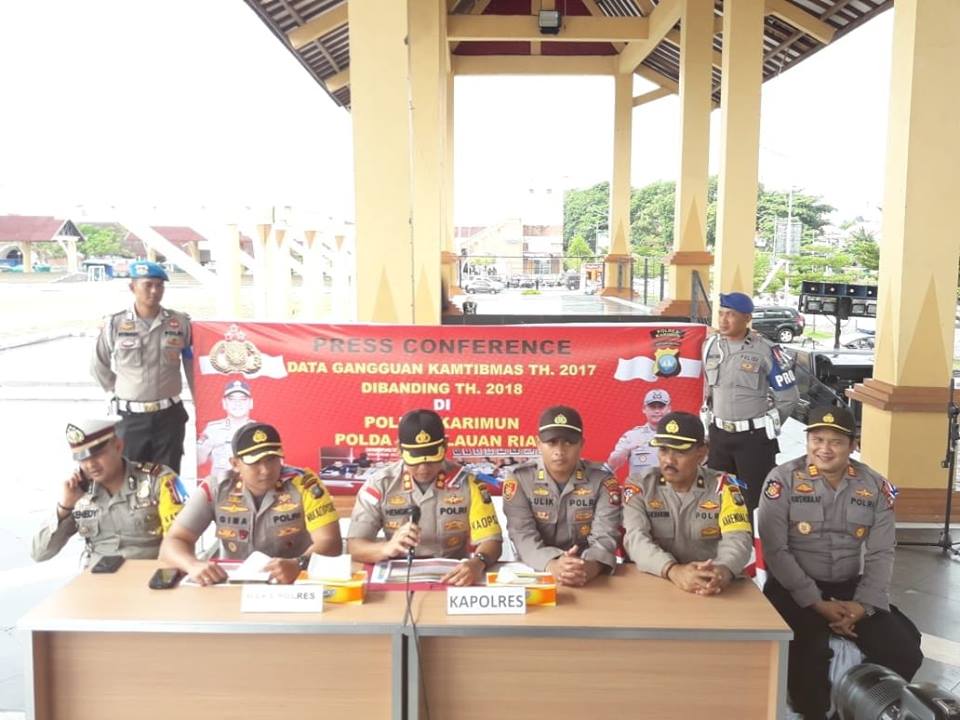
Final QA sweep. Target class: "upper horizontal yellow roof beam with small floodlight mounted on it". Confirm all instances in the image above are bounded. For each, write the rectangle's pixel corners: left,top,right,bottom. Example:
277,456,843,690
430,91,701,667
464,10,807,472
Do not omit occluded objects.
447,15,647,42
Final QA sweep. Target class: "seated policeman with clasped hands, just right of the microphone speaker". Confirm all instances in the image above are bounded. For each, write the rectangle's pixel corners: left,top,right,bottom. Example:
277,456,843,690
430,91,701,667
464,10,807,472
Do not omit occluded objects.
503,405,620,587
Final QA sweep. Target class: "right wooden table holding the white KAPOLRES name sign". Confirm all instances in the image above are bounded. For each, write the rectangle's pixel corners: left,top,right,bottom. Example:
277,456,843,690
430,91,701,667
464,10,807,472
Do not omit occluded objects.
407,565,791,720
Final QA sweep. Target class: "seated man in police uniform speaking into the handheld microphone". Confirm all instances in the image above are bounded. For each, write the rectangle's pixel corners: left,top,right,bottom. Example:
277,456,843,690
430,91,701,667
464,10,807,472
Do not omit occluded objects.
347,410,502,585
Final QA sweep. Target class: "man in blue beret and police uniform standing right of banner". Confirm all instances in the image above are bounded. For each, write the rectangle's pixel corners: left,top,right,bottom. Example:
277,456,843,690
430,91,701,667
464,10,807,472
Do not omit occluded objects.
704,293,800,513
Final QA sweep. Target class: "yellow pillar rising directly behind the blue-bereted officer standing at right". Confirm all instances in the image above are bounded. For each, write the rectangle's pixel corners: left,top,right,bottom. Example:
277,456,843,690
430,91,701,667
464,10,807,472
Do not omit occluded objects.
710,0,764,322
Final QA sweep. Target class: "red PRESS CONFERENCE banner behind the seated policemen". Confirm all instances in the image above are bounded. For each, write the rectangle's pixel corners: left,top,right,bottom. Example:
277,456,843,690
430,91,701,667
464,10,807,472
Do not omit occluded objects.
193,322,705,482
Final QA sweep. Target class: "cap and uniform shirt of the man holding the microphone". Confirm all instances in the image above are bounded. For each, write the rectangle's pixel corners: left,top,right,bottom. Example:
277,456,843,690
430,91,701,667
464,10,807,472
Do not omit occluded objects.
347,410,502,563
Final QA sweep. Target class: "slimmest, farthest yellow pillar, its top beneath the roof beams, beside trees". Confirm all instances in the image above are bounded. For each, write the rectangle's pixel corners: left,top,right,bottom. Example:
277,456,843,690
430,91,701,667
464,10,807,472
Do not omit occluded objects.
600,73,633,298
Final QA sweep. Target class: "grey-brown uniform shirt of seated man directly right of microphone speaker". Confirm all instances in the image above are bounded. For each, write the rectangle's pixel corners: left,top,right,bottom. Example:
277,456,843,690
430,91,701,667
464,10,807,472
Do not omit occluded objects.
503,459,620,571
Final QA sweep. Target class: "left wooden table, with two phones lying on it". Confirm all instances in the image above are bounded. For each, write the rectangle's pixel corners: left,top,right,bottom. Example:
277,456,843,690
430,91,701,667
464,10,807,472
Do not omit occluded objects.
21,560,404,720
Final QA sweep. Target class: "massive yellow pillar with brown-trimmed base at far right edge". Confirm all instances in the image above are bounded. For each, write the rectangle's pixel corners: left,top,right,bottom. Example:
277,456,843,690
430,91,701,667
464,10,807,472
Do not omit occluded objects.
848,0,960,521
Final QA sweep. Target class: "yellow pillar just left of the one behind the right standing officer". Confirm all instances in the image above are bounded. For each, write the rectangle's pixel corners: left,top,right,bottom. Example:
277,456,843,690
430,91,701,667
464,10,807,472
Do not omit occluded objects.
657,0,713,315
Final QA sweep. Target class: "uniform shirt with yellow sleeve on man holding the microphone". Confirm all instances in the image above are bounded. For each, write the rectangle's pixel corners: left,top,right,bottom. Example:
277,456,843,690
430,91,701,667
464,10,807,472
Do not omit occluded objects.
347,460,503,558
